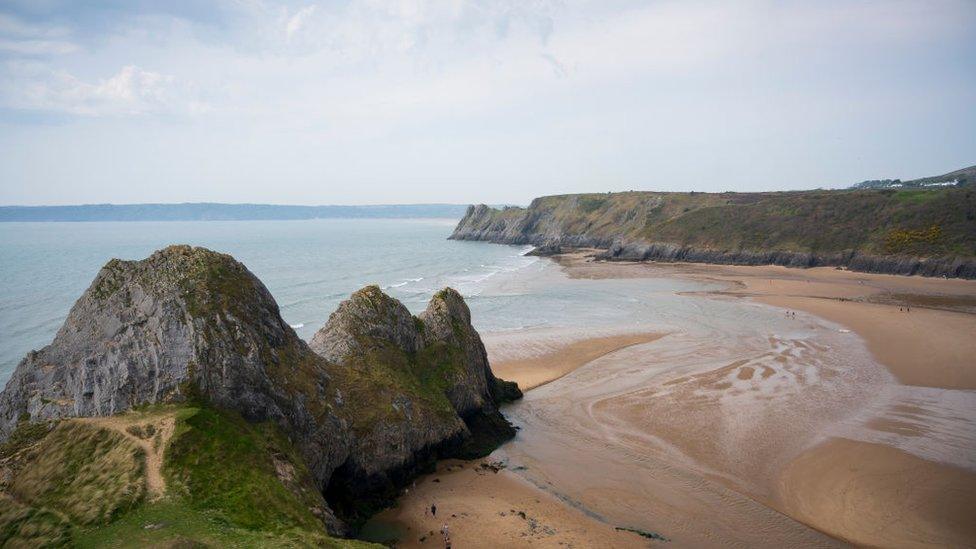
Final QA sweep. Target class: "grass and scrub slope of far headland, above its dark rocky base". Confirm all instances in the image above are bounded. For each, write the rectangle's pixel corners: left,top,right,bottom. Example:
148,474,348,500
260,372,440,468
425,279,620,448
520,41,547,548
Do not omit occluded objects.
500,187,976,257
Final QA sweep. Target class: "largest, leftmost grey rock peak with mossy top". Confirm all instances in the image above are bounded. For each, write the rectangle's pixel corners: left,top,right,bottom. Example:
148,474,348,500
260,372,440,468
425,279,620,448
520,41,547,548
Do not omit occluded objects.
0,246,329,436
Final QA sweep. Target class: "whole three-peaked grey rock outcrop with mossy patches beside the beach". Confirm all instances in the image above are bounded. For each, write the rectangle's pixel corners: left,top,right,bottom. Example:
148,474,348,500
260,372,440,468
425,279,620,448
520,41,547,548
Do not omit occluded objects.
0,246,521,533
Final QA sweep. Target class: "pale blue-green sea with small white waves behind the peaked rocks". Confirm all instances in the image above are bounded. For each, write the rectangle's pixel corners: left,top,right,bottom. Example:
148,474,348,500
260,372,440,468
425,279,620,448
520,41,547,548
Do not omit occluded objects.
0,219,672,387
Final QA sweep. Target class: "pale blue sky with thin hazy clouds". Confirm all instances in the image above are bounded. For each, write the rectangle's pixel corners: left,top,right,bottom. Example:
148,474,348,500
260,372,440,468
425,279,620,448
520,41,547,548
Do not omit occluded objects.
0,0,976,205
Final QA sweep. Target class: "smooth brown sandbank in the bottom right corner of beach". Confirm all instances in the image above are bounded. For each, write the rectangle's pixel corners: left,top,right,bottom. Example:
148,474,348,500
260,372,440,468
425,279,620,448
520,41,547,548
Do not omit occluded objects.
780,438,976,547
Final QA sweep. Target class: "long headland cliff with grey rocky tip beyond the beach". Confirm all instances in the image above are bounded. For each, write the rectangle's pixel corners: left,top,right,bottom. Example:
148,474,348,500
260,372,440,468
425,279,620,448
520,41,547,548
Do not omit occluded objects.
450,186,976,278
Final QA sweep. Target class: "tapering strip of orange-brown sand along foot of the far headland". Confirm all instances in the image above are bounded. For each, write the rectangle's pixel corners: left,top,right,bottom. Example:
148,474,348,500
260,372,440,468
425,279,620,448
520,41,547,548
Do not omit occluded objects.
560,254,976,389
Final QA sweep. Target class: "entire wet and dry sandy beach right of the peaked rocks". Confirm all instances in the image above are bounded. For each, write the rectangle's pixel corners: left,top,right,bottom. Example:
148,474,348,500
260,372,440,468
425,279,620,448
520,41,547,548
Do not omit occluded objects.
364,253,976,547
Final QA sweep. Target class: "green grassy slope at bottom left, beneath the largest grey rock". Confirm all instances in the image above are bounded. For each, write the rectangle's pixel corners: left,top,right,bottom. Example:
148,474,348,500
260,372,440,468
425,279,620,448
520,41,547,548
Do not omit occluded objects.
0,407,378,547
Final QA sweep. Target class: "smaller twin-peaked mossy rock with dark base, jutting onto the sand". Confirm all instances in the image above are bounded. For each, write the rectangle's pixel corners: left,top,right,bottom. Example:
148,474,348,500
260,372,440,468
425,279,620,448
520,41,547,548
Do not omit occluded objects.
310,286,521,515
